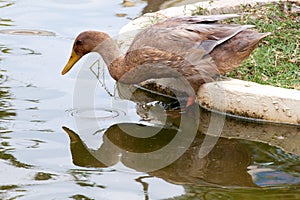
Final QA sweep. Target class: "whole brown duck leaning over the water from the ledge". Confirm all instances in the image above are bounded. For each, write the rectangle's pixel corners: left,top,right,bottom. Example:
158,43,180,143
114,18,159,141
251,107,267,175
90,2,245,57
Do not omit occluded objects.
62,14,269,98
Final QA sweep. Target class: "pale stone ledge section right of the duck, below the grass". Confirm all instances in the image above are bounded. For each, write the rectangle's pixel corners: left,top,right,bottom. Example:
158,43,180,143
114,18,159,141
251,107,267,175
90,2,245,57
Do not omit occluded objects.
197,79,300,125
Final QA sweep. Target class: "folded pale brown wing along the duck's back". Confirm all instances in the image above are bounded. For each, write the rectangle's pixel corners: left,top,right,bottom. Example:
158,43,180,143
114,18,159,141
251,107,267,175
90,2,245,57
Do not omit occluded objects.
129,14,253,55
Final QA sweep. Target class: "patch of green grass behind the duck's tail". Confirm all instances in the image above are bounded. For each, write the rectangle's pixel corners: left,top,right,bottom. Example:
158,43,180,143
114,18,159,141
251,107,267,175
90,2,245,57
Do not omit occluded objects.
194,2,300,90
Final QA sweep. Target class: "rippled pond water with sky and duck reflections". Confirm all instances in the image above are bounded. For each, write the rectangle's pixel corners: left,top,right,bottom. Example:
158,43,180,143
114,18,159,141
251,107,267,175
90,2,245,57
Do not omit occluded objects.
0,0,300,199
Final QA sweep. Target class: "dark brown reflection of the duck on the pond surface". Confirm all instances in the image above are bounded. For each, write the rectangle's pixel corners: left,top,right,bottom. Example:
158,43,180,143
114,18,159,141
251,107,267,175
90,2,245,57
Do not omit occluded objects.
63,123,255,186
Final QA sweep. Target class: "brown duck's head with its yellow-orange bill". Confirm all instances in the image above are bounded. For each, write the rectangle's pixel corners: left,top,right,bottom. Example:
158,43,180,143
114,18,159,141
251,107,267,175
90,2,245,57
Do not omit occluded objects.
61,31,109,75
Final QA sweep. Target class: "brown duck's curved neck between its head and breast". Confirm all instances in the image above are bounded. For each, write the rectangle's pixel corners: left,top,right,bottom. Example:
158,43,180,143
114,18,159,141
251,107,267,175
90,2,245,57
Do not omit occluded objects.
93,37,127,80
